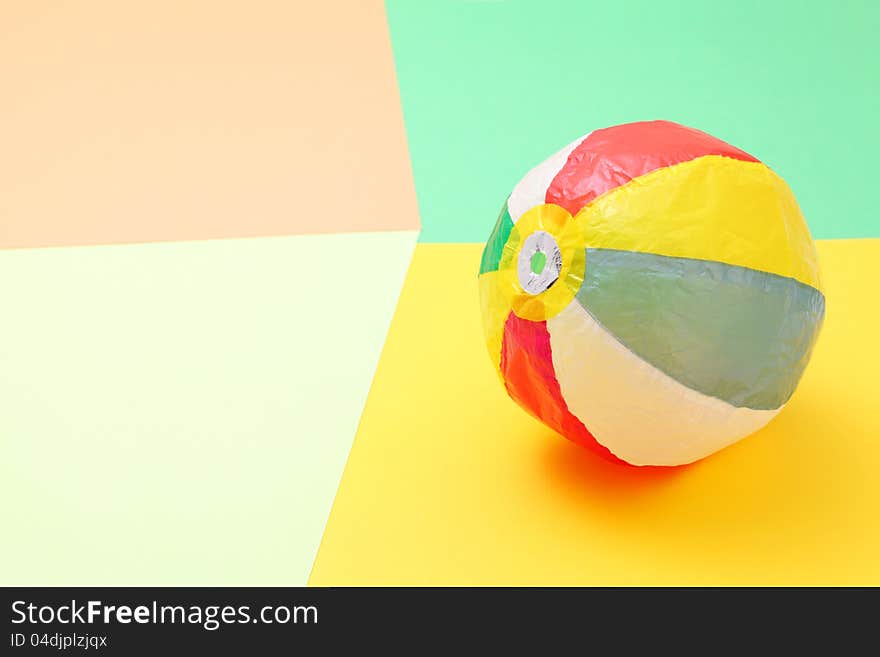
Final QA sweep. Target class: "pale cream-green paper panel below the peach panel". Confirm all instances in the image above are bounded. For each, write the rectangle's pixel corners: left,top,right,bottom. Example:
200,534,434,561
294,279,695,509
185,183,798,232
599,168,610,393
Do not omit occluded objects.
0,231,416,586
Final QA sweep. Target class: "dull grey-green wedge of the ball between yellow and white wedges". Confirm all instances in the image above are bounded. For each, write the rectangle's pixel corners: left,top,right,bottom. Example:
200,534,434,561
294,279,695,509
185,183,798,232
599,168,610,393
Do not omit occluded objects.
577,249,825,410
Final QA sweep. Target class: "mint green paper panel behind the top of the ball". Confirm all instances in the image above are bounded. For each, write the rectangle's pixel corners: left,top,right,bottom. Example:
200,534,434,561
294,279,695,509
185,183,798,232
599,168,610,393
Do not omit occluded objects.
386,0,880,242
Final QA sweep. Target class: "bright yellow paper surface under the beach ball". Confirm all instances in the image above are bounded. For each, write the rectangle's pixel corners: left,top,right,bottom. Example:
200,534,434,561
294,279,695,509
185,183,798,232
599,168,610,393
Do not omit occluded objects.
310,240,880,586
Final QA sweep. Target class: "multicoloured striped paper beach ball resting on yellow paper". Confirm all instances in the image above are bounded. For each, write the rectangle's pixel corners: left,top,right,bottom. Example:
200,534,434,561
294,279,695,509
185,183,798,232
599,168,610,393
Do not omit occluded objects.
479,121,825,465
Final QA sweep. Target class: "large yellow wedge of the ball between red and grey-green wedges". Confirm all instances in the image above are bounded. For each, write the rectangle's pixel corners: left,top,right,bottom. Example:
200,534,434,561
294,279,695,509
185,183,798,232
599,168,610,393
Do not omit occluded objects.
577,155,820,288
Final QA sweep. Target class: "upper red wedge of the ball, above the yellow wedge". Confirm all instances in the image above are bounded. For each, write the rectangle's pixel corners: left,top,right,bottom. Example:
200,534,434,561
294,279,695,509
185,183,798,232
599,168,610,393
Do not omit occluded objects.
545,121,758,215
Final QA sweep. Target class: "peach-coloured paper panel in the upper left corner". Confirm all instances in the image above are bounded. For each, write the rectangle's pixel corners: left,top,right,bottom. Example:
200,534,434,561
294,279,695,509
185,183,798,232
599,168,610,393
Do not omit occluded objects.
0,0,418,247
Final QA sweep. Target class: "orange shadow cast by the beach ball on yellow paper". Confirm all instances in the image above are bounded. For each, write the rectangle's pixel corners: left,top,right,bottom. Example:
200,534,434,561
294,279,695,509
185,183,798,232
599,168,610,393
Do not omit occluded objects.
535,376,848,536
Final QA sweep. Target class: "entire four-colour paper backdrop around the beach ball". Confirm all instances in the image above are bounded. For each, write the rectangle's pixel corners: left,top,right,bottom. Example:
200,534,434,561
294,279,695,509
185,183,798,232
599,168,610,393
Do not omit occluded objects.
0,0,880,585
